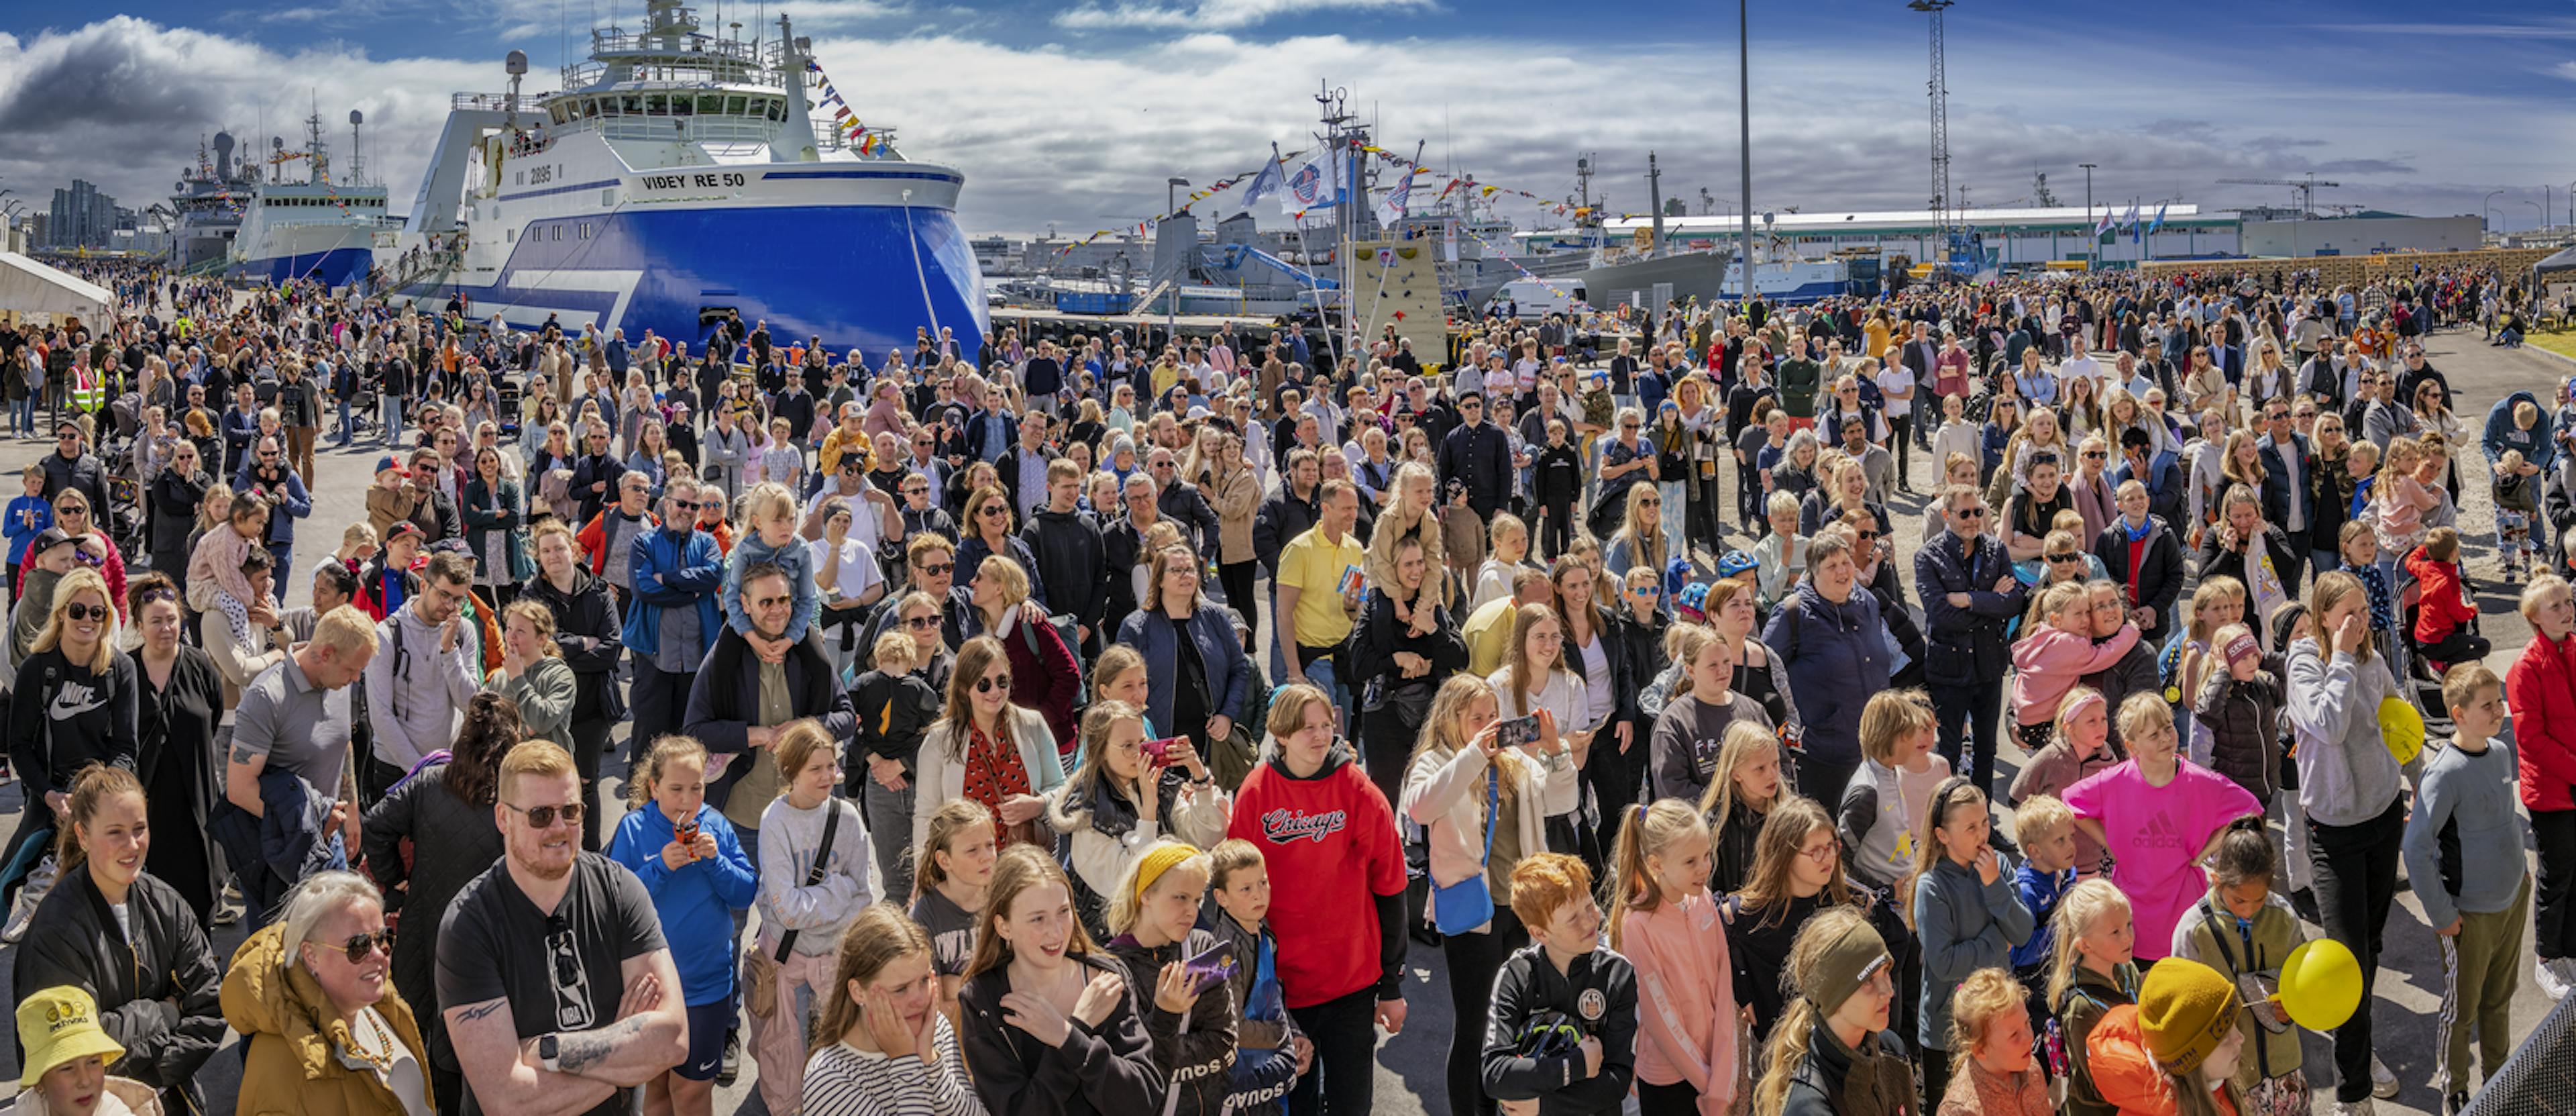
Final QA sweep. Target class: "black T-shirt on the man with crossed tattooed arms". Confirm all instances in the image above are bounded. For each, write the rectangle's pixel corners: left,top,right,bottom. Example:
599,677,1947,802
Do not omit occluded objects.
438,853,665,1116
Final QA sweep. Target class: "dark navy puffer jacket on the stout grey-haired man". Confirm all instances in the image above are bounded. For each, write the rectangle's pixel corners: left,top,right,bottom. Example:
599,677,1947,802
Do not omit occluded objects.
1762,580,1888,766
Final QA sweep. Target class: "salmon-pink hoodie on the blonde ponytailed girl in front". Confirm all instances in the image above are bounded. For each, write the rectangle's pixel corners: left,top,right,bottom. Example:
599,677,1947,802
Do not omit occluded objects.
1618,892,1736,1116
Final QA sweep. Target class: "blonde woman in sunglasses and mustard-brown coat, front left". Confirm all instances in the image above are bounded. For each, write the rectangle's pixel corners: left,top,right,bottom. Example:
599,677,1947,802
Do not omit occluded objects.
224,871,440,1116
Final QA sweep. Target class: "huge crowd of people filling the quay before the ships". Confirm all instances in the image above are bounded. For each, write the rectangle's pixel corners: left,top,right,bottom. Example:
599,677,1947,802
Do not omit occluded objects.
0,254,2576,1116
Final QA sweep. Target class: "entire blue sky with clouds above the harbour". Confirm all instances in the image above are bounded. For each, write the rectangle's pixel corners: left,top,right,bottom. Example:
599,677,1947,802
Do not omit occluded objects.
0,0,2576,234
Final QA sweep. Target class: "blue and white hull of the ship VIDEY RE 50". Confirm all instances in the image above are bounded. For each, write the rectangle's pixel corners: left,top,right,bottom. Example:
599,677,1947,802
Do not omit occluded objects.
402,203,989,356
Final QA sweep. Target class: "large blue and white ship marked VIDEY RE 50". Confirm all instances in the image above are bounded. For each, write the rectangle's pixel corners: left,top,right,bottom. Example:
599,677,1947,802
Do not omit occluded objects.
378,0,989,353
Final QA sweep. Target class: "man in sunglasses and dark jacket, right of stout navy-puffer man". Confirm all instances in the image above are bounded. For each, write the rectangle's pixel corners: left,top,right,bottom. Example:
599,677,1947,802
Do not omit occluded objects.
1914,485,2025,789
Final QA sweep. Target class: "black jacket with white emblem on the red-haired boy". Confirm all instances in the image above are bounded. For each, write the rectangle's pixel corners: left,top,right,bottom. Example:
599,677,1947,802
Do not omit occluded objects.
1460,944,1635,1116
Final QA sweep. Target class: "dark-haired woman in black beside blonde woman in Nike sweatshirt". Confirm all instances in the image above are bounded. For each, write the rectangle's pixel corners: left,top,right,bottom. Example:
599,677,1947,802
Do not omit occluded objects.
131,572,224,923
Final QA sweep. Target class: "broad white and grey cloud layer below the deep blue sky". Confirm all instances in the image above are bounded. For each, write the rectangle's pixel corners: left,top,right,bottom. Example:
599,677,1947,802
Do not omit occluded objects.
0,12,2576,234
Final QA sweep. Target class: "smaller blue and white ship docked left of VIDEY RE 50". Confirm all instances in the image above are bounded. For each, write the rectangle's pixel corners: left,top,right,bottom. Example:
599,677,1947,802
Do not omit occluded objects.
224,111,402,286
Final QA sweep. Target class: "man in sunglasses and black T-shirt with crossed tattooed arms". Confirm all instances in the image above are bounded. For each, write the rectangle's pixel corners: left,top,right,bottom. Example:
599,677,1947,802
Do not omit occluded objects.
437,740,690,1116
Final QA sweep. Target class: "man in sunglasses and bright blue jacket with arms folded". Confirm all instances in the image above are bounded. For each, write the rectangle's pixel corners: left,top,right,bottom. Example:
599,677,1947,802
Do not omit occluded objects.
610,477,716,763
